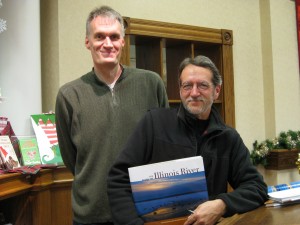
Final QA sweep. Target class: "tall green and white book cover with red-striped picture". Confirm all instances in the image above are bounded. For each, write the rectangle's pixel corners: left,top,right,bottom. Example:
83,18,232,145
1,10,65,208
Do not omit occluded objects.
31,113,63,165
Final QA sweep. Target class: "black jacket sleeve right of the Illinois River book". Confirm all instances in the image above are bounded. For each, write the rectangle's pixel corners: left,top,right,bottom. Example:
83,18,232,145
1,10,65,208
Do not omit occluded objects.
217,132,268,217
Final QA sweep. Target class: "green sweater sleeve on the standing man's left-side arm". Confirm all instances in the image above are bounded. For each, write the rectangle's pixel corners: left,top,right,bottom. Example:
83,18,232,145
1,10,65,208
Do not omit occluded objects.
55,90,76,175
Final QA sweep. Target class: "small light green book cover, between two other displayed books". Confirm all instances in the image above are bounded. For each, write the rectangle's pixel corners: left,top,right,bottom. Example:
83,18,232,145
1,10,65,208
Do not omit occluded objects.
18,136,41,166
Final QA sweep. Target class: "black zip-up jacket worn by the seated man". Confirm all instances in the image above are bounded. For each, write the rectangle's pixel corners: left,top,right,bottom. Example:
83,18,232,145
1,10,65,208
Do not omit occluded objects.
108,106,267,225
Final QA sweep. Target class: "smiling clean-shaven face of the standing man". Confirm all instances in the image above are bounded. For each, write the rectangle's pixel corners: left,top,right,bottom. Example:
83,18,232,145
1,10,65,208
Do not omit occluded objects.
85,16,125,67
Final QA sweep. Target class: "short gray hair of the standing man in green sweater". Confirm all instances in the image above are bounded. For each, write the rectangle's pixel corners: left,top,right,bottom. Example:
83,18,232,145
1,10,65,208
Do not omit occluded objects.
86,6,125,37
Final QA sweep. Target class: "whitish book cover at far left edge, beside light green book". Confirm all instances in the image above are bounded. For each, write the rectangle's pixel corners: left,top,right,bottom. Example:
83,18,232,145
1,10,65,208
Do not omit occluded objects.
0,135,20,170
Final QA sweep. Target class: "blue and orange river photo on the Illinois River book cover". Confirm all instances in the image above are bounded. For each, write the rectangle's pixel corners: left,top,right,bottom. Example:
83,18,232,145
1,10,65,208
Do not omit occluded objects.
131,171,208,222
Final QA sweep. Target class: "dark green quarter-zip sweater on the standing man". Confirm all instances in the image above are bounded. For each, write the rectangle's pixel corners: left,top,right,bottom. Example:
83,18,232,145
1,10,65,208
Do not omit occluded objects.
55,67,168,223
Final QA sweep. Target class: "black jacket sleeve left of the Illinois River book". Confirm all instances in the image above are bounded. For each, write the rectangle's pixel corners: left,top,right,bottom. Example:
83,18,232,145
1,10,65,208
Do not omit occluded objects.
107,113,153,225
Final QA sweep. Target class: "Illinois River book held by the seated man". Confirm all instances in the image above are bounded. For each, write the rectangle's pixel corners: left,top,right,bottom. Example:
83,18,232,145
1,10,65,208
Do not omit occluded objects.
128,156,208,222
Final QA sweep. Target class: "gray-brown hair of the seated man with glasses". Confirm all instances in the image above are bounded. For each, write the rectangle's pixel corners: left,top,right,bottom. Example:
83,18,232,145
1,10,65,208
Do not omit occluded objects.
178,55,222,86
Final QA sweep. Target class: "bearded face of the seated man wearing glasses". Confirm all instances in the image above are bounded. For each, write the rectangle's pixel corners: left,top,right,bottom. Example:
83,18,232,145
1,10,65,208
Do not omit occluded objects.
180,65,221,120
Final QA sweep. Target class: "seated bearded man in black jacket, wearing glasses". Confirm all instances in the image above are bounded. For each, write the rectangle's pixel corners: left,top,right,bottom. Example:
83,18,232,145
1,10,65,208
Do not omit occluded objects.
108,56,267,225
